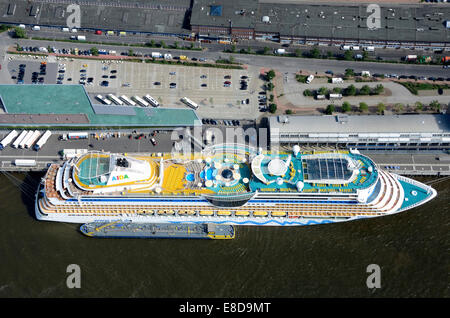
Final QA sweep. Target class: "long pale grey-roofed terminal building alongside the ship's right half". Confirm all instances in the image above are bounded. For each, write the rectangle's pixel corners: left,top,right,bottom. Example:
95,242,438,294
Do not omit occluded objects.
269,114,450,150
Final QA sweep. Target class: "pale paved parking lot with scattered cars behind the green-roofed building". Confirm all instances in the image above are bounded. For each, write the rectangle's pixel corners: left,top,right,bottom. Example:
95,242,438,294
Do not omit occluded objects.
10,53,263,119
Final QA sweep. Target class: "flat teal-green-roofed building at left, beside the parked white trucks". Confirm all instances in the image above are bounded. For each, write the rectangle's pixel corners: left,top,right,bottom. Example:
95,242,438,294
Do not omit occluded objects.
0,84,201,128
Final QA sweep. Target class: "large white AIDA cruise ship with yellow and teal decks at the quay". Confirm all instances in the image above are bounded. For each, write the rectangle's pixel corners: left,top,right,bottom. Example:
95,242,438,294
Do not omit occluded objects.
35,144,436,226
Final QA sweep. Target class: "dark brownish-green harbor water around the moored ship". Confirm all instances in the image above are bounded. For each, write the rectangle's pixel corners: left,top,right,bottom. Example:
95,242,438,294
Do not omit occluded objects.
0,173,450,298
